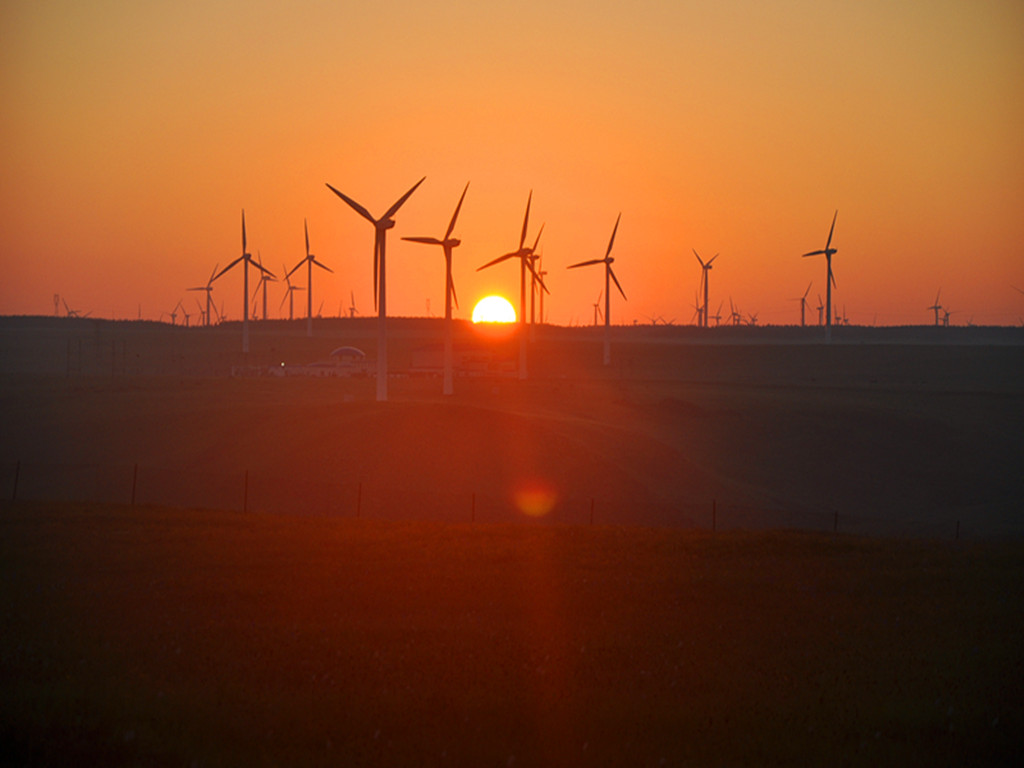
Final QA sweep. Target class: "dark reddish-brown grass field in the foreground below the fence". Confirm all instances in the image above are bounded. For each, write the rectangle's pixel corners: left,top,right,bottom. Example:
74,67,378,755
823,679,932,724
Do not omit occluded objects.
0,503,1024,766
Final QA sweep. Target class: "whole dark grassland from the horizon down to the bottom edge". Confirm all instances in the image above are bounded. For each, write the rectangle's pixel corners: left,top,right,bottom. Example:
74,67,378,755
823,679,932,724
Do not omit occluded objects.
0,318,1024,765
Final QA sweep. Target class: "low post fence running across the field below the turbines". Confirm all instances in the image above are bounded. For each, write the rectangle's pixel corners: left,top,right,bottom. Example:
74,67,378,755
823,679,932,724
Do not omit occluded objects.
0,462,991,539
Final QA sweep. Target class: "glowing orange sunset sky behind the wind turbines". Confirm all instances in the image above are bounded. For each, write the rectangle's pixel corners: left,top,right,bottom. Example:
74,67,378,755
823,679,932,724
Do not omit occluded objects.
0,0,1024,325
